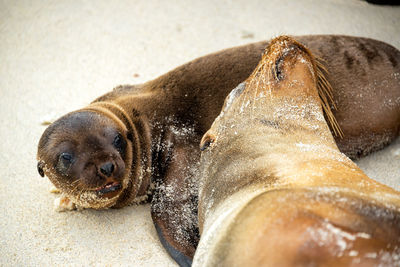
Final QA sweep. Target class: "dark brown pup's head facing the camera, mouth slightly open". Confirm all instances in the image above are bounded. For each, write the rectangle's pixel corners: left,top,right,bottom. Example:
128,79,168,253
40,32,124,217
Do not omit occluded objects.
37,109,137,209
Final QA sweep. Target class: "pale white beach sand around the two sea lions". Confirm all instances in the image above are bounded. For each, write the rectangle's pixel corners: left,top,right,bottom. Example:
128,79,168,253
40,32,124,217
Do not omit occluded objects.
0,0,400,266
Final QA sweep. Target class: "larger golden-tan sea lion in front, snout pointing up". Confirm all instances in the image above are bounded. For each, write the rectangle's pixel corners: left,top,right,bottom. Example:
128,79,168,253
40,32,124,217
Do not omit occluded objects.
193,36,400,267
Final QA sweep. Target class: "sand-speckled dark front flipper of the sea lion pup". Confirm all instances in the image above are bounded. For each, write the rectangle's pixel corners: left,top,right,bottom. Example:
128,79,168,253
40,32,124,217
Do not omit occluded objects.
151,143,200,266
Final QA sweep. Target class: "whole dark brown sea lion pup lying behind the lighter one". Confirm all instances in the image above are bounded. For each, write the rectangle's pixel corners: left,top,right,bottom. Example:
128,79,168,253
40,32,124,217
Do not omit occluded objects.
38,35,400,262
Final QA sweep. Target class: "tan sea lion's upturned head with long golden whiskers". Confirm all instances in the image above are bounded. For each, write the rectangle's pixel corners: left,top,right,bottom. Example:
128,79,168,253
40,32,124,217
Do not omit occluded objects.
200,36,343,151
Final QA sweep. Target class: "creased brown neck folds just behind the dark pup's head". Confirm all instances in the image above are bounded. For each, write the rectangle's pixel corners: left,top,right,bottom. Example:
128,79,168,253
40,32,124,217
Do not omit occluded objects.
85,102,152,207
